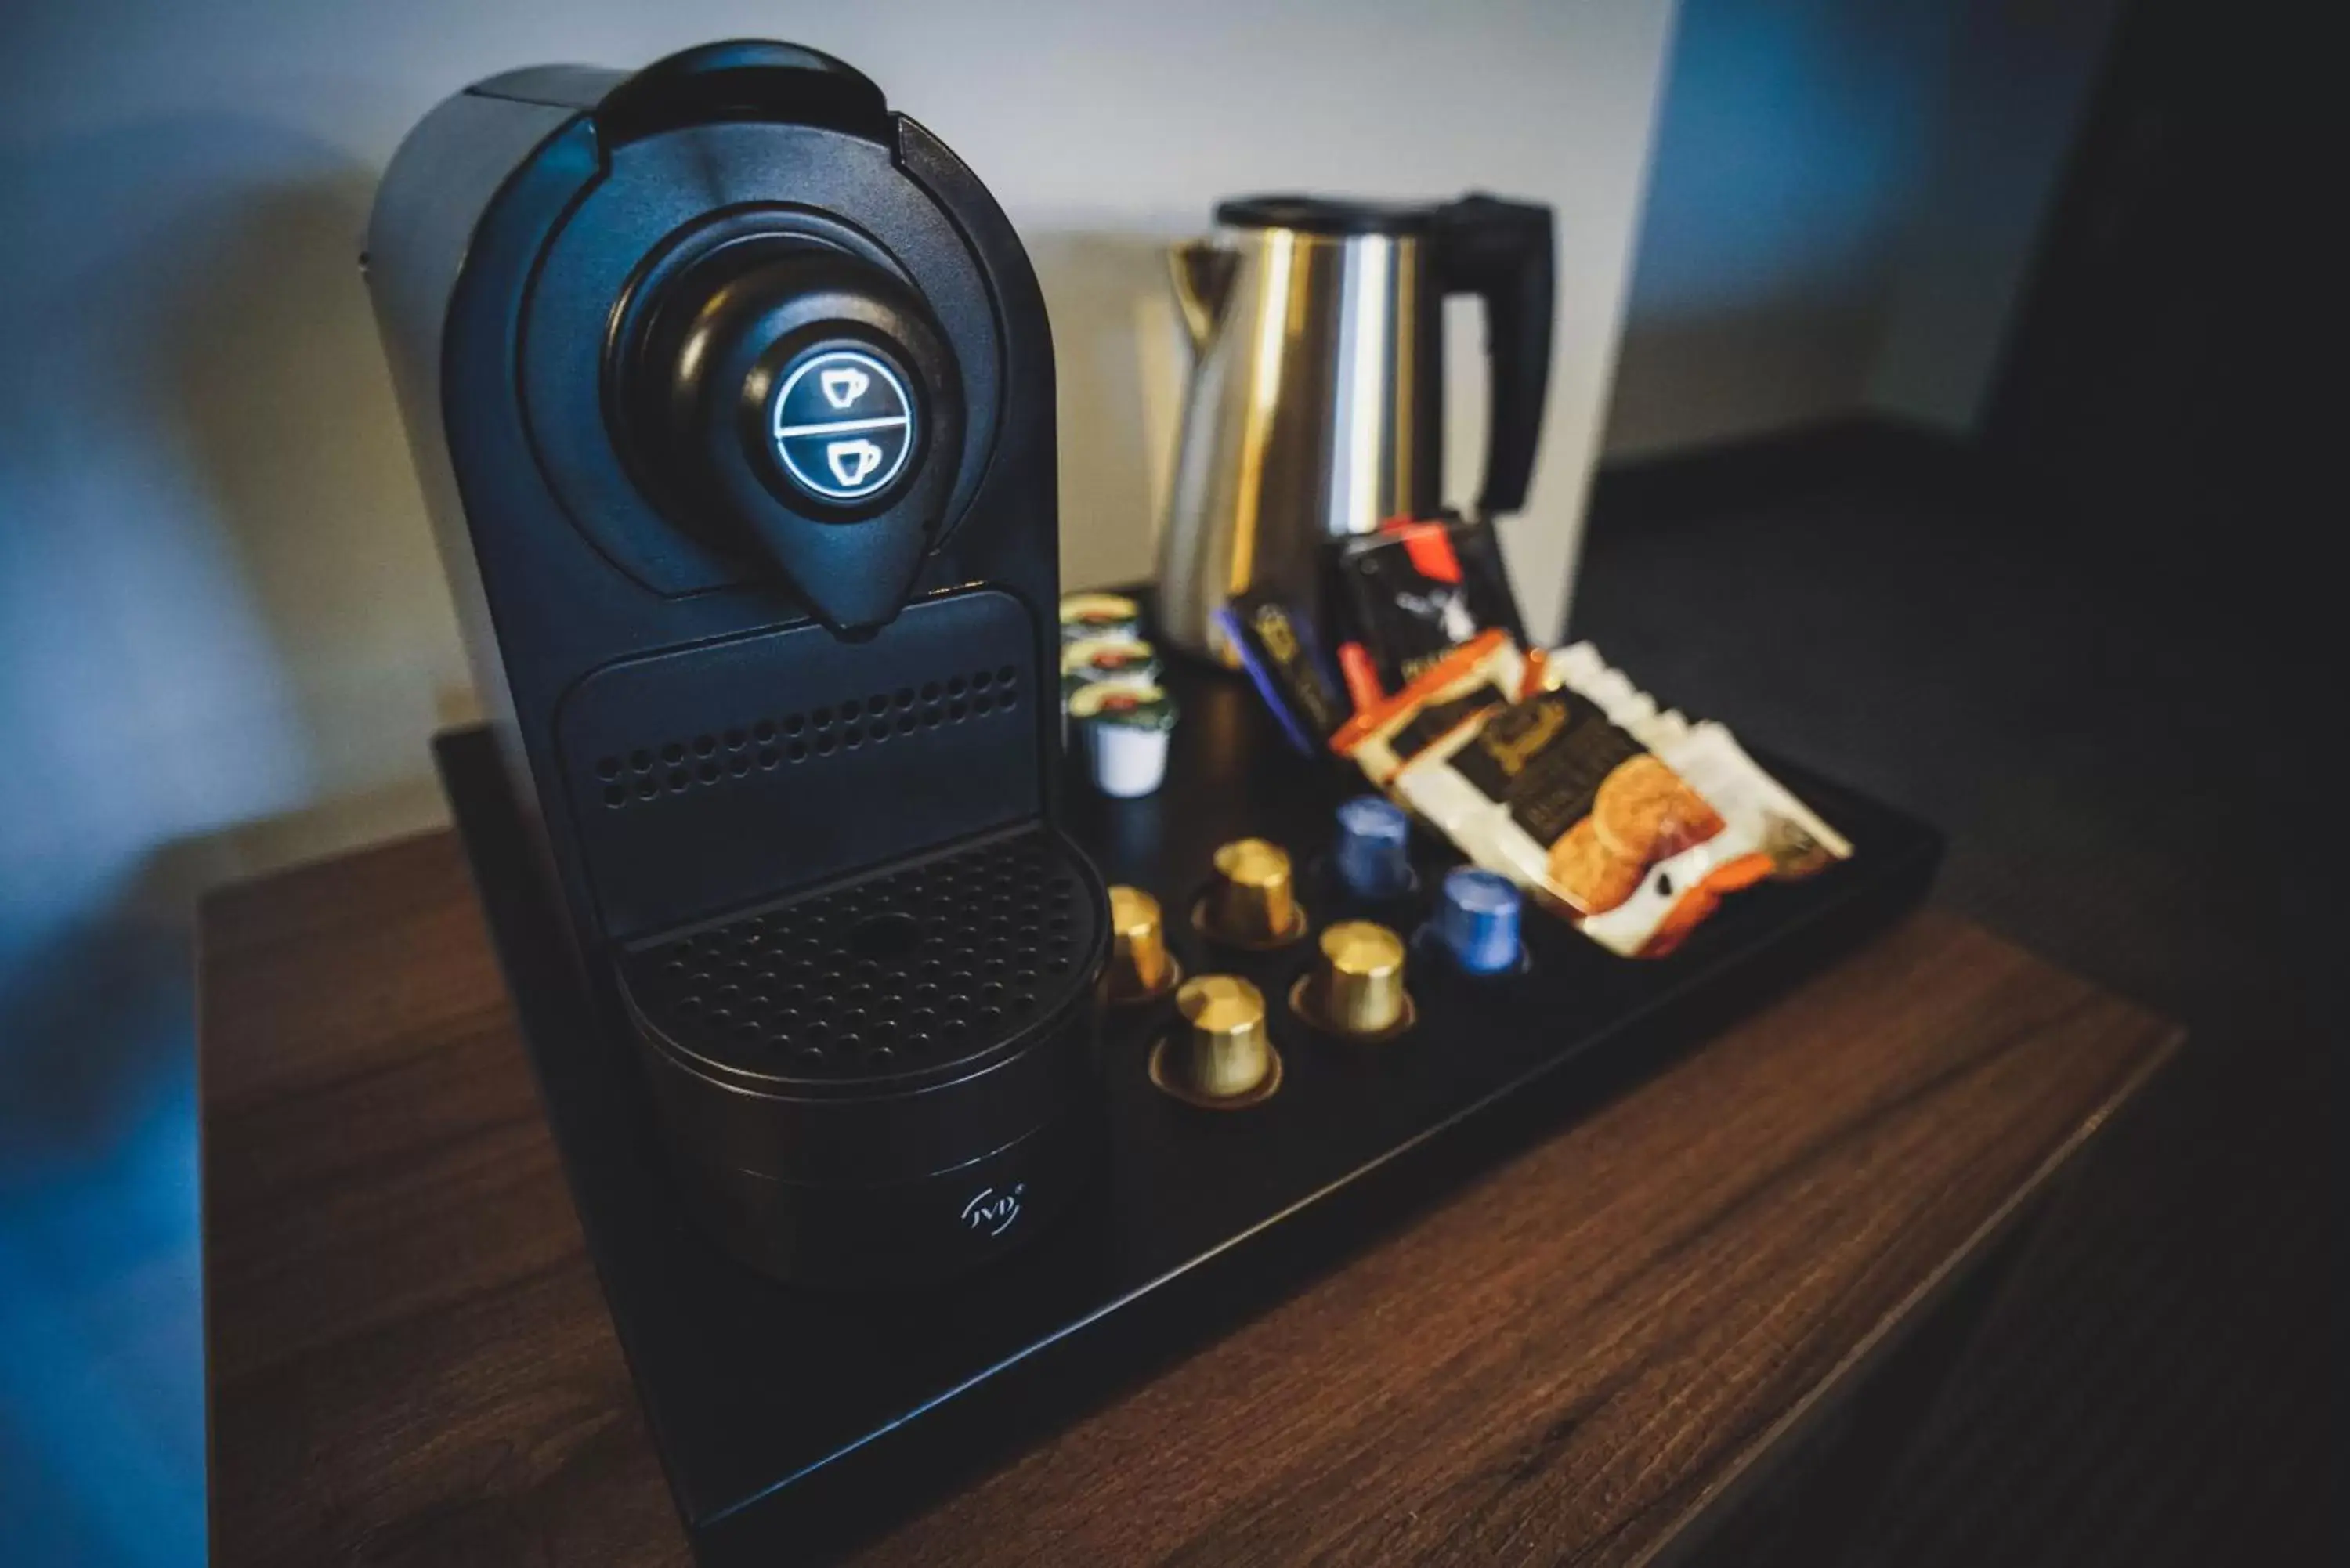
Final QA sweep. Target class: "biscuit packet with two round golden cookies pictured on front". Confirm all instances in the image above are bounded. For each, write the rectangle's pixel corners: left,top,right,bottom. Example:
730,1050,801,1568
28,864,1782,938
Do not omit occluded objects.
1332,634,1852,957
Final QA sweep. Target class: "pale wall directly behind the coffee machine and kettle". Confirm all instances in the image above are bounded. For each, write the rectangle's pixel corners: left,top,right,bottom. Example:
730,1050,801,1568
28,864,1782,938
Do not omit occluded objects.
0,0,1673,955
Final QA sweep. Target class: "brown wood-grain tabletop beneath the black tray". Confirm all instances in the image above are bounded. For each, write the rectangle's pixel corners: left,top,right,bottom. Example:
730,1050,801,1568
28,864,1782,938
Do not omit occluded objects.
200,835,2178,1568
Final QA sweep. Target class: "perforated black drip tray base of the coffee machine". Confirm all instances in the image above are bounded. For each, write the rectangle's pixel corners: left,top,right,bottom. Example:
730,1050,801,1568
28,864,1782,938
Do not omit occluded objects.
613,826,1107,1286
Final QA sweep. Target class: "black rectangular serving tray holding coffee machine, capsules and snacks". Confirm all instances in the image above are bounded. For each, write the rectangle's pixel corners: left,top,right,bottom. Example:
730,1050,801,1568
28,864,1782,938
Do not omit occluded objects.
435,670,1941,1566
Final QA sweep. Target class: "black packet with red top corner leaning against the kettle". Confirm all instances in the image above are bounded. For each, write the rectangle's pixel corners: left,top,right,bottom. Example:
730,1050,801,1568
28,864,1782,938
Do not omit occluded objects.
1337,517,1525,691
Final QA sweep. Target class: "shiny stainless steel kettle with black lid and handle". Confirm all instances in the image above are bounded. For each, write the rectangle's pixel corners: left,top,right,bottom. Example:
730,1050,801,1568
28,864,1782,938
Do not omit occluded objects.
1159,195,1553,663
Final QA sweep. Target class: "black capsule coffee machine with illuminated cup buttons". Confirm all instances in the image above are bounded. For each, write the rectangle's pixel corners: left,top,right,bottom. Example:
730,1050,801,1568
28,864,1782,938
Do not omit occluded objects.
367,42,1107,1286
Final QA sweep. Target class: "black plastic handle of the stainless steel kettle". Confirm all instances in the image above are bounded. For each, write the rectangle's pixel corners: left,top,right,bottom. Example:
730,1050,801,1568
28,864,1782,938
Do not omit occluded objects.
1436,193,1558,517
